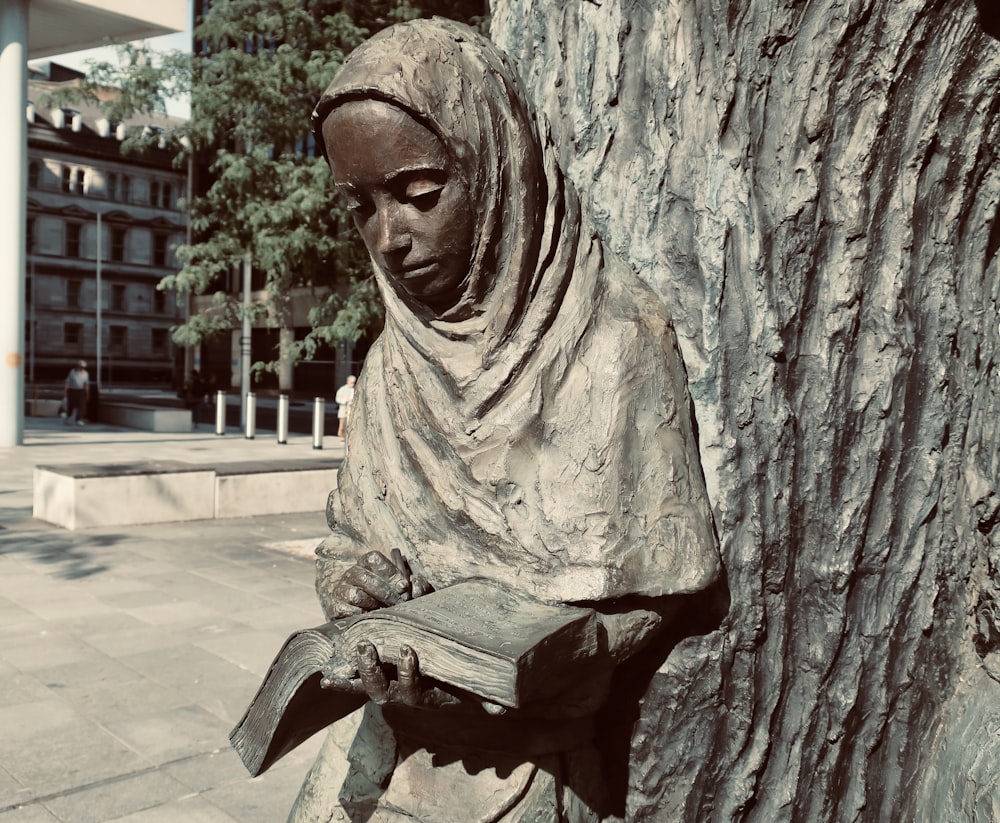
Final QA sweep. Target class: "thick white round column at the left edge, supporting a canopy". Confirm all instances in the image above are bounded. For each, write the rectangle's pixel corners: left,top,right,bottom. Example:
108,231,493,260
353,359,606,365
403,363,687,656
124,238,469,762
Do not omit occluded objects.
0,0,28,446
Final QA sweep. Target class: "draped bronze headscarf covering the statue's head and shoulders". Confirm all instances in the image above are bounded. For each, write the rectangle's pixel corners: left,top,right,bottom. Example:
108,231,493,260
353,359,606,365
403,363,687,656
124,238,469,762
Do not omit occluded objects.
313,18,718,601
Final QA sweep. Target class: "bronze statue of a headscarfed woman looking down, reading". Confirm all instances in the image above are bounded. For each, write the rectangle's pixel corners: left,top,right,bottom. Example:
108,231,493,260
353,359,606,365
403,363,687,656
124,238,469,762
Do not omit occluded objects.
290,19,720,821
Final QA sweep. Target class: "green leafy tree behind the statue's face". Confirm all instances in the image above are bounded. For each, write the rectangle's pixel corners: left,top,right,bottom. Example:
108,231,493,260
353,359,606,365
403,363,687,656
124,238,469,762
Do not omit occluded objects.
53,0,486,368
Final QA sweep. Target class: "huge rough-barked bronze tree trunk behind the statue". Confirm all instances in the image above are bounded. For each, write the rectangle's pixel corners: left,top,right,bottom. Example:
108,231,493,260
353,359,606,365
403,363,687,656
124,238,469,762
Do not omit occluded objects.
492,0,1000,823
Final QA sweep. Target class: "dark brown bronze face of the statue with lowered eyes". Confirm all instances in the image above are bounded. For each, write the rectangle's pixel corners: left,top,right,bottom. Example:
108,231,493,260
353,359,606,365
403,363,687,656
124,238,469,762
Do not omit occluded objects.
323,100,474,309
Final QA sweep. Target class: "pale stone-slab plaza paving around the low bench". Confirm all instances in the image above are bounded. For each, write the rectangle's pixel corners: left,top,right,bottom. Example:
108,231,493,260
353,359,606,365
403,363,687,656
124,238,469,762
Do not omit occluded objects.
0,418,343,823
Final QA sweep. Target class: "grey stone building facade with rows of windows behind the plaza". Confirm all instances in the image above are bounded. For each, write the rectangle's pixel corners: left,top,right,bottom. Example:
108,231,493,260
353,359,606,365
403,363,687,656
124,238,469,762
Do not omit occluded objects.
25,63,187,386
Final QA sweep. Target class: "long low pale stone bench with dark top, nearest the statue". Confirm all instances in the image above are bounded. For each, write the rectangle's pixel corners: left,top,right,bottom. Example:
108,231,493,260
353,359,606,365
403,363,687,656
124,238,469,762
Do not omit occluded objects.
32,458,341,530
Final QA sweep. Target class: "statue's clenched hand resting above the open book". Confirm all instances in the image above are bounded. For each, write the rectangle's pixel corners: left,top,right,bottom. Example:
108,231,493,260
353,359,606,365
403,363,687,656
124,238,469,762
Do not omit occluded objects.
324,549,431,620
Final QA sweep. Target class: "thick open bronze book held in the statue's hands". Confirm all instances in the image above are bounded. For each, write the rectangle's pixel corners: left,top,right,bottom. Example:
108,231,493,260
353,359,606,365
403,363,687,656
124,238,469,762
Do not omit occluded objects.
229,580,598,775
